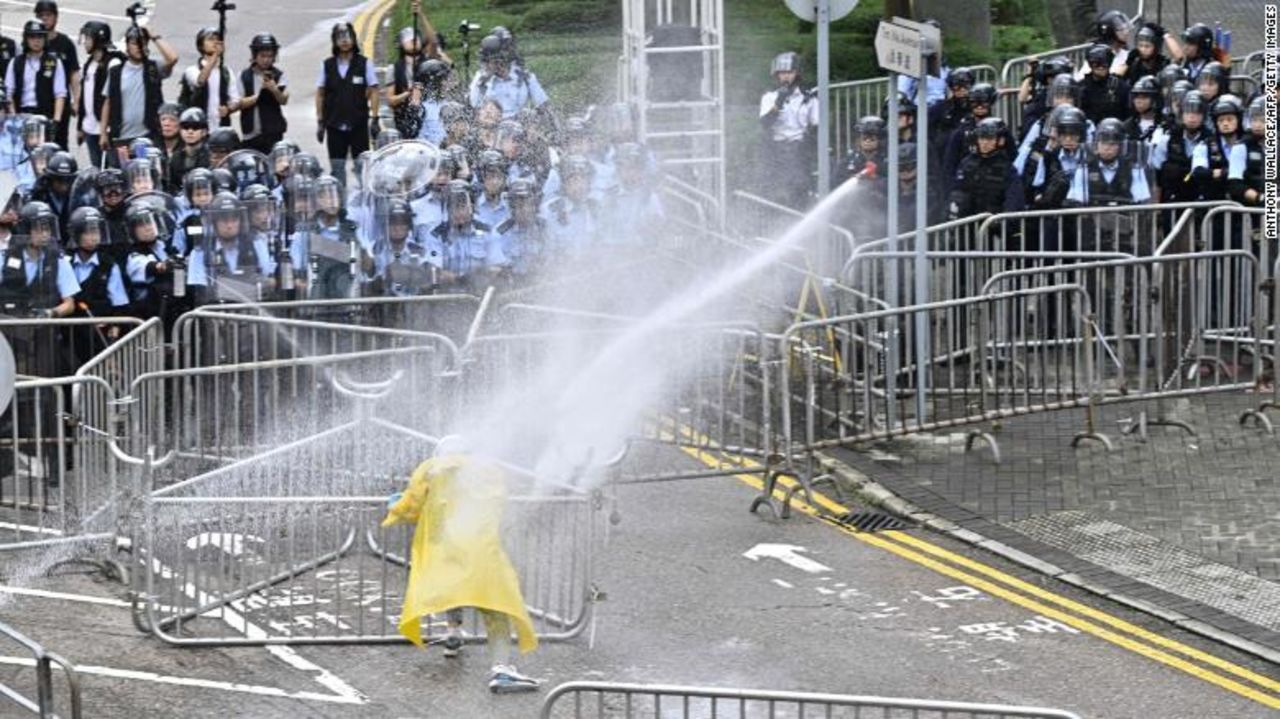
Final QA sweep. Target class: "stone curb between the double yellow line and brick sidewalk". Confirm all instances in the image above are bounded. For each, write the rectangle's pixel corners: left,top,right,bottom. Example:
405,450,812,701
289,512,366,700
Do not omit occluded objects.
817,453,1280,664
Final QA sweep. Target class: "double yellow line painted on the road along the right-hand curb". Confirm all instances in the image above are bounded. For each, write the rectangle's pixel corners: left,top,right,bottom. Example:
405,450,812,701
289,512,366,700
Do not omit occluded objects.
680,438,1280,709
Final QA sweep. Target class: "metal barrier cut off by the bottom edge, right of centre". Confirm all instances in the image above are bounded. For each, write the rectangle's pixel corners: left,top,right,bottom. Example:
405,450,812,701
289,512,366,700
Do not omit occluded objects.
540,682,1080,719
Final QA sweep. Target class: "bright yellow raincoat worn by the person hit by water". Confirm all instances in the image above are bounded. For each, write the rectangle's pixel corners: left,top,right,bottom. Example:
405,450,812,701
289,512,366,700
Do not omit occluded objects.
383,454,538,654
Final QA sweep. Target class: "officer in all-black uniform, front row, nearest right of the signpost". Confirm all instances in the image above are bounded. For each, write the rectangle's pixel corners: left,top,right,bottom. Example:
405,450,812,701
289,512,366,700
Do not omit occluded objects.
947,118,1023,220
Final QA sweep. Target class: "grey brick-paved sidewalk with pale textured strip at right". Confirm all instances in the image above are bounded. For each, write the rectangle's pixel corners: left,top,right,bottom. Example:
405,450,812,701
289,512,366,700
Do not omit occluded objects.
829,393,1280,656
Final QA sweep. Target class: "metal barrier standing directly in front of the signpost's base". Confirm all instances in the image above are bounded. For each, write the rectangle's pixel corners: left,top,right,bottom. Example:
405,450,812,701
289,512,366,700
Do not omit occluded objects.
780,285,1110,458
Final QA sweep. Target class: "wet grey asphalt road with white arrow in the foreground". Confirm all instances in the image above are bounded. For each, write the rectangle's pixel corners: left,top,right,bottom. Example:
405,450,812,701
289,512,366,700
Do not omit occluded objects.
0,453,1280,719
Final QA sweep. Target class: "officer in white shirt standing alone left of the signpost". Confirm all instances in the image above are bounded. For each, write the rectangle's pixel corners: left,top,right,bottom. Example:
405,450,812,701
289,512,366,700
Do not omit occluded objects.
759,52,818,209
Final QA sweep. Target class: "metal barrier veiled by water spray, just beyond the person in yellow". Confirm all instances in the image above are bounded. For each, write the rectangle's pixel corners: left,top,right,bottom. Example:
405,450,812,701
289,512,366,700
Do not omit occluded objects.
460,316,776,484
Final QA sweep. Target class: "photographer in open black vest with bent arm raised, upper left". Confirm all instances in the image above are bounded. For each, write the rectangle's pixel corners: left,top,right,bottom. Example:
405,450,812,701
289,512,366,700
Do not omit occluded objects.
101,22,178,166
